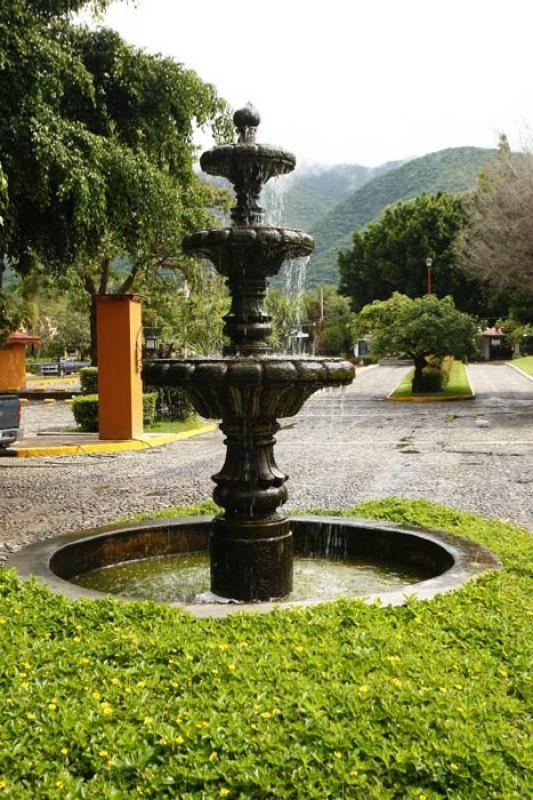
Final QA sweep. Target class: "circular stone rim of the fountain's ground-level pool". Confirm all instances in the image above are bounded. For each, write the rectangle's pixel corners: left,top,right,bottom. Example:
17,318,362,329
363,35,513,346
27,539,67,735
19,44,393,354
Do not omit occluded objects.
5,514,502,618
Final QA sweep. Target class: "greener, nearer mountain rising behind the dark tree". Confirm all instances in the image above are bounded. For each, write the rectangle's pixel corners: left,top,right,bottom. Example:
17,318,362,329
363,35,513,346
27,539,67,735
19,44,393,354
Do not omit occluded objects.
306,147,496,288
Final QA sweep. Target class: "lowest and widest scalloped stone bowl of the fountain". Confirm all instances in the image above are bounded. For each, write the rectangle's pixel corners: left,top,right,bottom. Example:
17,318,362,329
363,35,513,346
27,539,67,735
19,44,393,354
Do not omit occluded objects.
143,356,355,419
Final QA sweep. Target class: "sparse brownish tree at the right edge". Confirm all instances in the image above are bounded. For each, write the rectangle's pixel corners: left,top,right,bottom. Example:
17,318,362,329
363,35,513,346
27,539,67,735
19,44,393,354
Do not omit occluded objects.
458,136,533,310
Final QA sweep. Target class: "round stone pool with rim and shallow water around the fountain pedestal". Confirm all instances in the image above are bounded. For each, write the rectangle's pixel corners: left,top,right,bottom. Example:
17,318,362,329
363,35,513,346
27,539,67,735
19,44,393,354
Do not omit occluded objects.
7,516,501,617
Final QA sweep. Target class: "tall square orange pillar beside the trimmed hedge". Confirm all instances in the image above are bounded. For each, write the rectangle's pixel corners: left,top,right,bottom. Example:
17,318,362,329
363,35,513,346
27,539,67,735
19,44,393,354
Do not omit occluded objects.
96,294,143,439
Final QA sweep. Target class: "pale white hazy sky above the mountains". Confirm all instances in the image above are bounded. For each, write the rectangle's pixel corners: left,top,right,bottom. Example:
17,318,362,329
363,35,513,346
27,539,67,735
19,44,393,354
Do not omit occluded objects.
91,0,533,165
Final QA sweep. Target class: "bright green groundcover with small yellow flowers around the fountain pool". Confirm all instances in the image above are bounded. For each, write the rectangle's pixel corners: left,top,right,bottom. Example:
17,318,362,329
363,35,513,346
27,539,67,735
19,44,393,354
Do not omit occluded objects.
0,499,533,800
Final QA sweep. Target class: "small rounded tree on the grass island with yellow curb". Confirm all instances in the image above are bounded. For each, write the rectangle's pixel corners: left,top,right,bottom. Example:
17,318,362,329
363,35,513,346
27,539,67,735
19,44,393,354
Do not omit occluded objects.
356,292,477,392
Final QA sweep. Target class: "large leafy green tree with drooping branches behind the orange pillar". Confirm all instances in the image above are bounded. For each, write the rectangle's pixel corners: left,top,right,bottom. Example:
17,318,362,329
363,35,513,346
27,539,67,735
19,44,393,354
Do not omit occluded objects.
0,0,230,360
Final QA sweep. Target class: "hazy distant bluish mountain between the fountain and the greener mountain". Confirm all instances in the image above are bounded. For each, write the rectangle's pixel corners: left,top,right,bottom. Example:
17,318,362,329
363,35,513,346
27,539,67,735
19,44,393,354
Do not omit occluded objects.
280,161,400,230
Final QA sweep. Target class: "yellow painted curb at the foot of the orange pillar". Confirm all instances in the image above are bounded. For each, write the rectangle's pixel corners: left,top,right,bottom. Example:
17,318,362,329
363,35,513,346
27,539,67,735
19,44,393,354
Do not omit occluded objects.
10,422,217,458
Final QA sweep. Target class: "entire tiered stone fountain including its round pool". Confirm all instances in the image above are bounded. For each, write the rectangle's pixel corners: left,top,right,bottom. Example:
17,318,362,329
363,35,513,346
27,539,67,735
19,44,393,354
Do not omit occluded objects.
8,106,499,616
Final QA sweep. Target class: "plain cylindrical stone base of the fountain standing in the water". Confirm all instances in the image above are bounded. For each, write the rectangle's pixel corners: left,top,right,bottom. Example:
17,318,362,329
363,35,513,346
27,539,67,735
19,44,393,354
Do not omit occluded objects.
210,516,293,600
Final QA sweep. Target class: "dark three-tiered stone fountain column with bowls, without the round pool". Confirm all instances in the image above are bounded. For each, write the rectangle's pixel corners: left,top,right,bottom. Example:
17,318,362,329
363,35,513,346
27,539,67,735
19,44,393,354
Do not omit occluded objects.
144,105,355,600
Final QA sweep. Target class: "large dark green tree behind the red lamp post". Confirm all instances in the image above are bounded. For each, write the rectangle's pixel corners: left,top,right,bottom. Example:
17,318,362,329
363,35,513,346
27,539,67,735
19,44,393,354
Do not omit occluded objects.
339,193,483,313
